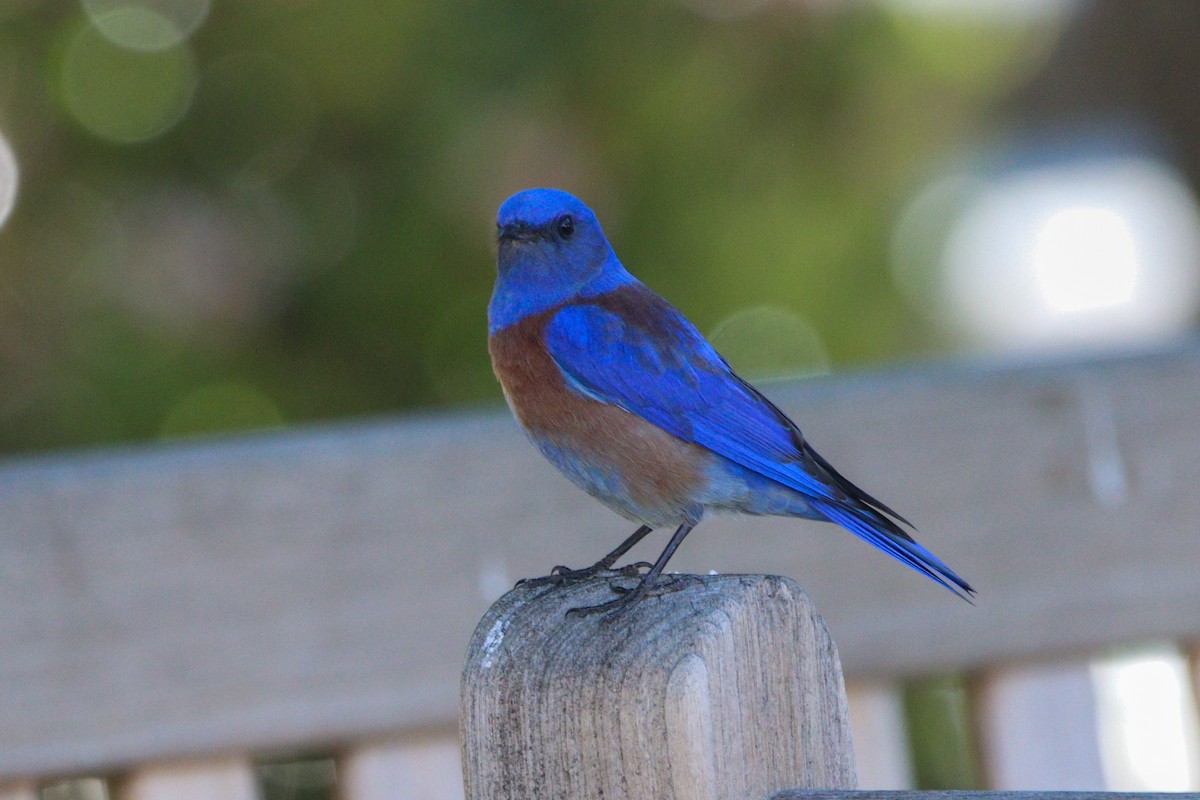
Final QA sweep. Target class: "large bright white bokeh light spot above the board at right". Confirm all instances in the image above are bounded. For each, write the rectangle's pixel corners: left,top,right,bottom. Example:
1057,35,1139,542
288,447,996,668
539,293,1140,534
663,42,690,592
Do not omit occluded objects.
893,154,1200,350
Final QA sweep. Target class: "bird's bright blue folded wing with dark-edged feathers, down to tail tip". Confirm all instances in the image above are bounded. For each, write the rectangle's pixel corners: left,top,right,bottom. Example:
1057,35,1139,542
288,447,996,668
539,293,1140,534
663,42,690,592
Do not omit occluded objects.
545,285,971,599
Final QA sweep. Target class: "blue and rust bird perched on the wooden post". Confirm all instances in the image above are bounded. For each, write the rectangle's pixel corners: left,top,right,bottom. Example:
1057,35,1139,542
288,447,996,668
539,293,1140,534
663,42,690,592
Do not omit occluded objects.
487,188,976,615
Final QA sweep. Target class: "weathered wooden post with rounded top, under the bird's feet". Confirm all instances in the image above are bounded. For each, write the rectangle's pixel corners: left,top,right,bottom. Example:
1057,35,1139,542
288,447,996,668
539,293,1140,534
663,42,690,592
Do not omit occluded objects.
461,576,856,800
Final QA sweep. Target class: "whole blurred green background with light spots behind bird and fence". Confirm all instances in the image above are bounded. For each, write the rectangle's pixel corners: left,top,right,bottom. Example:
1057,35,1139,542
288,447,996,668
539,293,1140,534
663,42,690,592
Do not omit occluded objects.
7,0,1200,796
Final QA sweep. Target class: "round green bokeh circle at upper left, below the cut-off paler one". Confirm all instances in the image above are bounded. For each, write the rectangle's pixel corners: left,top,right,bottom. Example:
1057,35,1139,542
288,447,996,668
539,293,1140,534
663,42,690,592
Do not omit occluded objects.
61,25,196,143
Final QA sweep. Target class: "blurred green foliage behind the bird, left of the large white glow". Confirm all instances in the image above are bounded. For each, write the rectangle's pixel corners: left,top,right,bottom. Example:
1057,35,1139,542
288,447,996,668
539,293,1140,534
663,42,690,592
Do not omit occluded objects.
0,0,1040,451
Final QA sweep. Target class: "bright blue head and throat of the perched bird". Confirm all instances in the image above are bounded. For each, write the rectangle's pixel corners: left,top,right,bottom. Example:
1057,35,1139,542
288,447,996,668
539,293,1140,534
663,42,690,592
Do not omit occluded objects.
487,188,634,333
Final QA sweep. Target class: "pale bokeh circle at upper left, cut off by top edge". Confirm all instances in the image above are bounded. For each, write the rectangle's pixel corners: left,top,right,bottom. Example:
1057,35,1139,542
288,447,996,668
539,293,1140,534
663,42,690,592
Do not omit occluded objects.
83,0,211,50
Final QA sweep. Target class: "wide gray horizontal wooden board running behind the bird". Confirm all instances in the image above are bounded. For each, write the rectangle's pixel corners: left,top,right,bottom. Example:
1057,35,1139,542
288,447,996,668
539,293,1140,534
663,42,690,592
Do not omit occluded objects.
0,343,1200,778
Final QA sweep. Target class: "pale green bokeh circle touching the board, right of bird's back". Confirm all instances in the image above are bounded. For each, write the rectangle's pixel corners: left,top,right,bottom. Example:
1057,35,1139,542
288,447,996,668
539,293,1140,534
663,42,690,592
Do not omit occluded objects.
709,306,829,379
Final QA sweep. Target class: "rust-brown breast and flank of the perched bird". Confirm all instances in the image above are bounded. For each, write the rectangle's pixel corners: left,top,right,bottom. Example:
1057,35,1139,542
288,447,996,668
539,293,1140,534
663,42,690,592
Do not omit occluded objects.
488,303,713,522
